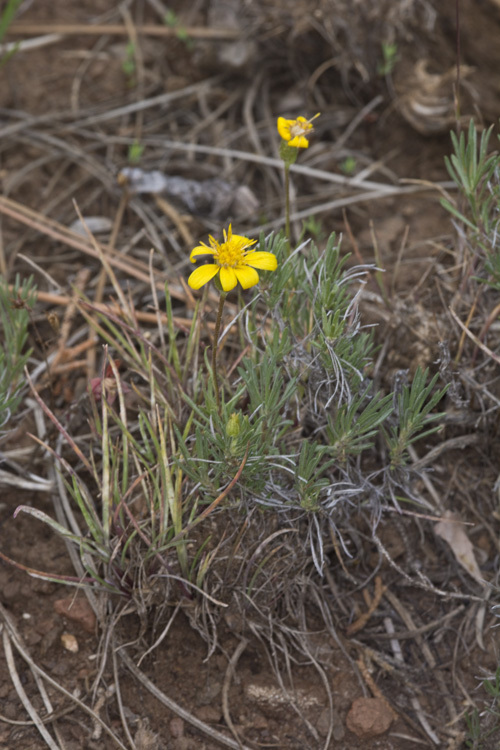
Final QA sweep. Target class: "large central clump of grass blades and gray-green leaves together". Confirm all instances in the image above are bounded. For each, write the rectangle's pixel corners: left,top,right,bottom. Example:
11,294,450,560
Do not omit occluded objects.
11,228,445,611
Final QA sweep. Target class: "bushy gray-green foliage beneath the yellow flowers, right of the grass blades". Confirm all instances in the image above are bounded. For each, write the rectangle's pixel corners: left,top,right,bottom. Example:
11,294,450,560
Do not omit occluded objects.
176,236,446,568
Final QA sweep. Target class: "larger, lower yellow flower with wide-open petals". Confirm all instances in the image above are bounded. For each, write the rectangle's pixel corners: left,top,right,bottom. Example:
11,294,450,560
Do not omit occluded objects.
188,224,278,292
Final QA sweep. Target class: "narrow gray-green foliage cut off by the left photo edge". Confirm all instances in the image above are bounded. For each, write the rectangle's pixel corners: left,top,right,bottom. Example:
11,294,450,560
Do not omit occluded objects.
0,277,34,428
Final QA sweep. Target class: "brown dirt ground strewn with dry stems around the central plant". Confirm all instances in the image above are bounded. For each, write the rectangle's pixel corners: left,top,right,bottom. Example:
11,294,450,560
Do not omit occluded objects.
0,0,500,750
